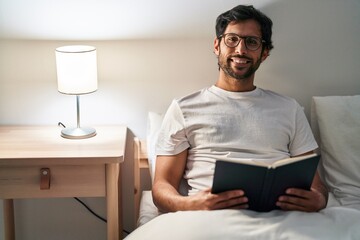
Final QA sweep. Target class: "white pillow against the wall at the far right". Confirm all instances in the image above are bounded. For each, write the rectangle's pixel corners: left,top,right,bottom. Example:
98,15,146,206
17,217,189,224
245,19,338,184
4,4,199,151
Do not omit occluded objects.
312,95,360,208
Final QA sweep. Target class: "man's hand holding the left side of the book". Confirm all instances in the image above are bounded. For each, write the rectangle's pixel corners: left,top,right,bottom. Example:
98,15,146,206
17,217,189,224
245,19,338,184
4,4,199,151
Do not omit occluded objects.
187,189,248,210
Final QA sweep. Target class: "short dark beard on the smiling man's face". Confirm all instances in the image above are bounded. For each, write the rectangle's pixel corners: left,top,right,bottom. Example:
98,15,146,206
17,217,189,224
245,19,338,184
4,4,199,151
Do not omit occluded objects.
218,52,261,80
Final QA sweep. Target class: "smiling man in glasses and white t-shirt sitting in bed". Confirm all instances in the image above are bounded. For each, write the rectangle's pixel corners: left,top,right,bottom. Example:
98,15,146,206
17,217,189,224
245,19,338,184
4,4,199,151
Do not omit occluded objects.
153,5,327,212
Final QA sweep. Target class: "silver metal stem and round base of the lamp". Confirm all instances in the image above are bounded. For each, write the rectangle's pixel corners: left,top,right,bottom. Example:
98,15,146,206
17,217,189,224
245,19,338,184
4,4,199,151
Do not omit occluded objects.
61,95,96,139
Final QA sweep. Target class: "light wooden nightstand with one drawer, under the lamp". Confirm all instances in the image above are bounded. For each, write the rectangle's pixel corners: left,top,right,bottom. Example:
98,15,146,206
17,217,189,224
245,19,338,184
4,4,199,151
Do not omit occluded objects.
0,126,127,240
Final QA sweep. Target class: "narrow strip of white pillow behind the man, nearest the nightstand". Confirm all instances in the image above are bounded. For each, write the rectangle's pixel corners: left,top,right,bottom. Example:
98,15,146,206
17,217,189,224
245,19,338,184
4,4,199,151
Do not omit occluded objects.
146,112,164,182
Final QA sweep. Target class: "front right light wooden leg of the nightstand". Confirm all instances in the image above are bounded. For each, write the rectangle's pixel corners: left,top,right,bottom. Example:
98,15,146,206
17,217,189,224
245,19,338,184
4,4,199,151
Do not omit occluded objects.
106,163,122,240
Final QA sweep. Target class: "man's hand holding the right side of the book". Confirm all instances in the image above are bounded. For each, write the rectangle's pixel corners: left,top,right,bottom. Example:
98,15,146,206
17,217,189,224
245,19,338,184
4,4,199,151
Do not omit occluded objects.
276,188,327,212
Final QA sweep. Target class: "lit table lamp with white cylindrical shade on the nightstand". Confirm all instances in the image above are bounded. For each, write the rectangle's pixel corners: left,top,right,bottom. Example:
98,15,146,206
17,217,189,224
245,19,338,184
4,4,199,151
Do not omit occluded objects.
55,45,97,139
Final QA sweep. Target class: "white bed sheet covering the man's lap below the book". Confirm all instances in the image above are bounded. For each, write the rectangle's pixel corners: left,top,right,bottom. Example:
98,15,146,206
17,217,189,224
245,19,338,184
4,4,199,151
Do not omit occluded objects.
126,206,360,240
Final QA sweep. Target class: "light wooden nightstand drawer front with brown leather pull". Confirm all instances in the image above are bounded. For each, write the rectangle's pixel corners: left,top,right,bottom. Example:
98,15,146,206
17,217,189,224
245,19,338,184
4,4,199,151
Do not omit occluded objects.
0,165,106,199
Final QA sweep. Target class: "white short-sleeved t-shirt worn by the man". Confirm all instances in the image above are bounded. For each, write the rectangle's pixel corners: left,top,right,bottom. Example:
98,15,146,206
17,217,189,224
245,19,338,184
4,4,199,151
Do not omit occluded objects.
156,86,317,195
